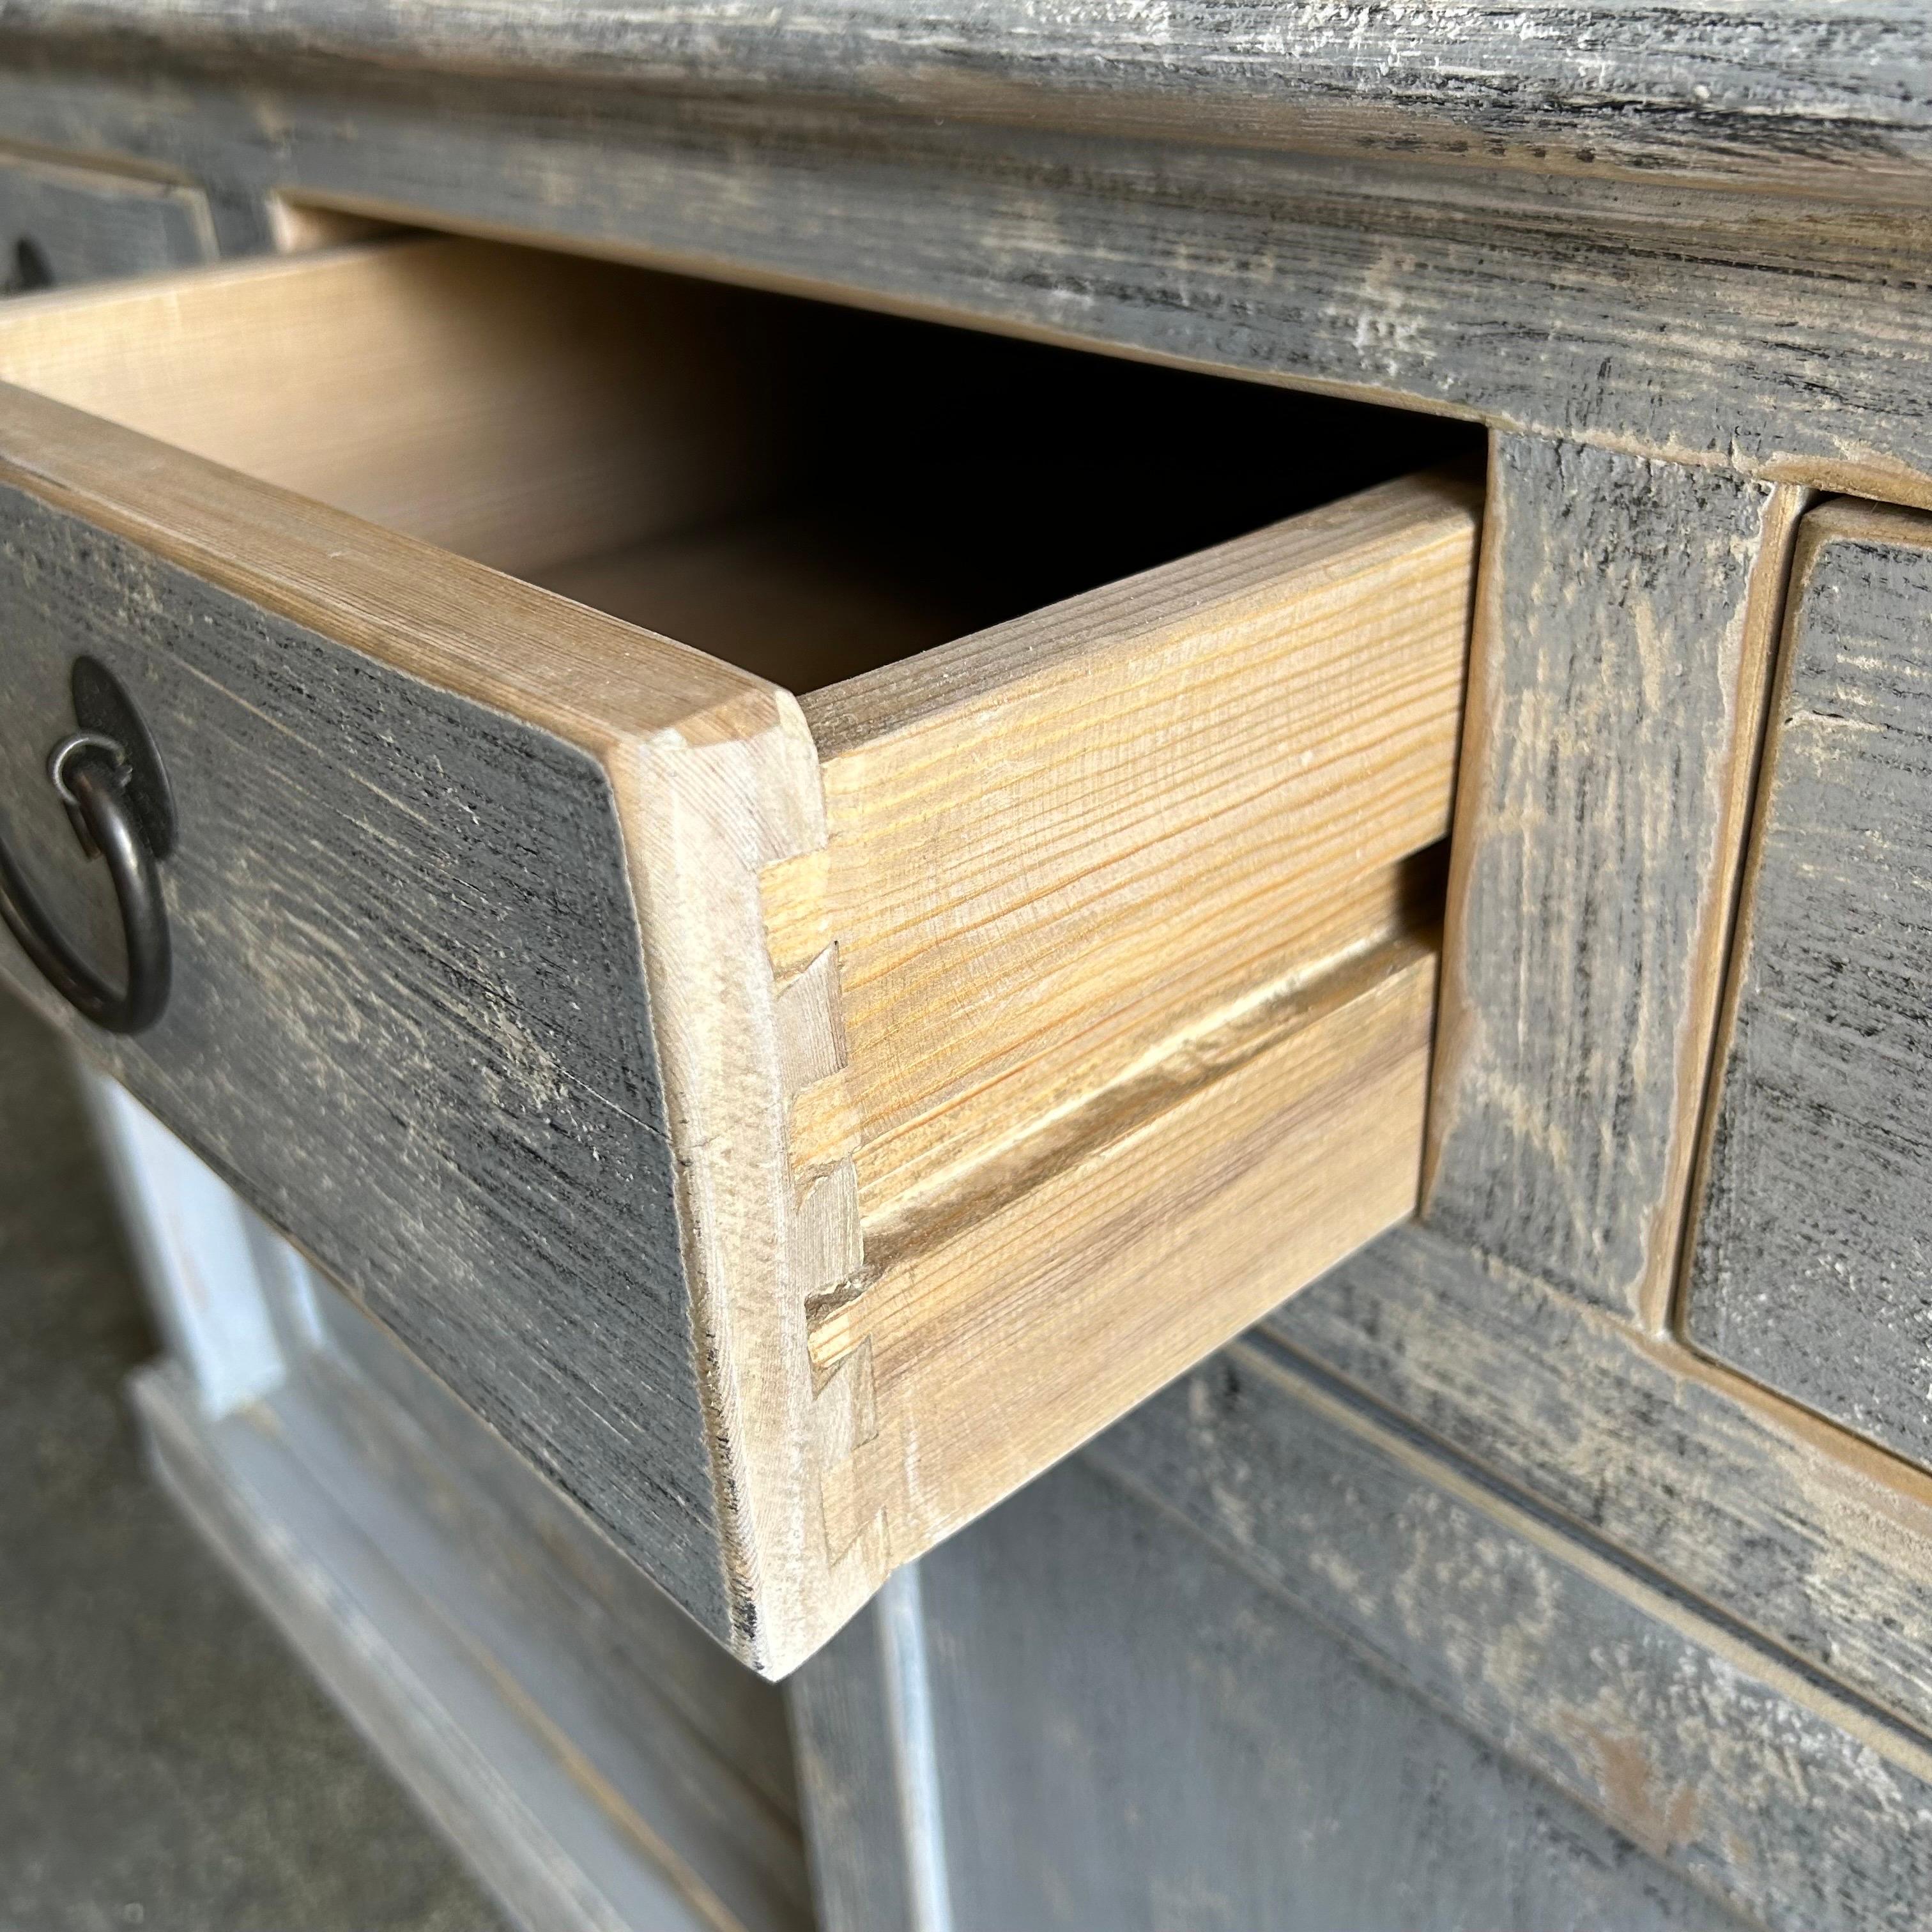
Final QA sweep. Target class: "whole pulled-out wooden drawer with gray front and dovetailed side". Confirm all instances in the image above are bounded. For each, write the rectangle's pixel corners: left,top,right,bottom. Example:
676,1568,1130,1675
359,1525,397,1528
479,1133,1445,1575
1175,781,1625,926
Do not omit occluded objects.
0,240,1480,1675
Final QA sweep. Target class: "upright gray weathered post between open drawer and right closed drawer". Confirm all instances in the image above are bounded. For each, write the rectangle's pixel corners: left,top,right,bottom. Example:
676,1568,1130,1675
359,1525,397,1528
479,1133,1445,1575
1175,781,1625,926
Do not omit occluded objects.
1424,436,1797,1325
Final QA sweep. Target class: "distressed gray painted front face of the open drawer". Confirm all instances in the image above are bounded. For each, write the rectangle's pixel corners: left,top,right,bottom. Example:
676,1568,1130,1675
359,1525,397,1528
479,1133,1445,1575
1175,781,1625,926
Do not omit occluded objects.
0,479,728,1634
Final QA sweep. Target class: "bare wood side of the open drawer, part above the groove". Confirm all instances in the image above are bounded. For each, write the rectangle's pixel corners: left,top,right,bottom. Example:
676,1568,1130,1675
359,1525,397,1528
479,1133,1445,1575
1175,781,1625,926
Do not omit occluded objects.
799,475,1480,1246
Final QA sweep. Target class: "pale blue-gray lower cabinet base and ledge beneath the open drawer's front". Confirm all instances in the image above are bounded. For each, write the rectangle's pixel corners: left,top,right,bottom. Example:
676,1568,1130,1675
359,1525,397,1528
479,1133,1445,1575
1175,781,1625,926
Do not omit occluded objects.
91,1035,809,1932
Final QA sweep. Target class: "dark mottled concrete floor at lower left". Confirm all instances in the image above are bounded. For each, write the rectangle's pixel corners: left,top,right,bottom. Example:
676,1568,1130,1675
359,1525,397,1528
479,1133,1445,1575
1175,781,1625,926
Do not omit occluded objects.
0,991,502,1932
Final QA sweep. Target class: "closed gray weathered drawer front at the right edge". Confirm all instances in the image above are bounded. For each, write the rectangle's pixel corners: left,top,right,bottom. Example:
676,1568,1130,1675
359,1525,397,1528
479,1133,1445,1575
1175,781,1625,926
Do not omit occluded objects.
1685,502,1932,1462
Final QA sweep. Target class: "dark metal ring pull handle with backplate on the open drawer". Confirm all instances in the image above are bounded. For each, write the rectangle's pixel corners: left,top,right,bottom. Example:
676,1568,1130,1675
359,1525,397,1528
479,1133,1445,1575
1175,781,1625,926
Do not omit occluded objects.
0,657,174,1034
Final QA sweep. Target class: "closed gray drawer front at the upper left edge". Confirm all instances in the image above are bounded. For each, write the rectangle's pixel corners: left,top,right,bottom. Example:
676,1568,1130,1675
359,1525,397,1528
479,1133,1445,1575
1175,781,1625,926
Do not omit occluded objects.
0,157,217,294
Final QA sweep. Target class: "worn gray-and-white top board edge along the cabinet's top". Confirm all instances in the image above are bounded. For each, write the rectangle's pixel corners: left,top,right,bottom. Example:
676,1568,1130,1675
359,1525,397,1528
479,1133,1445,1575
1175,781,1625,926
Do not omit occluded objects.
0,0,1932,197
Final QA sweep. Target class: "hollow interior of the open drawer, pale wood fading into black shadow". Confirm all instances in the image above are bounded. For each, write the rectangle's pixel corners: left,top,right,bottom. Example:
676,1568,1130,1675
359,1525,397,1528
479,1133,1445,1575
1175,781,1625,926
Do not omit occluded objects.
4,240,1474,692
